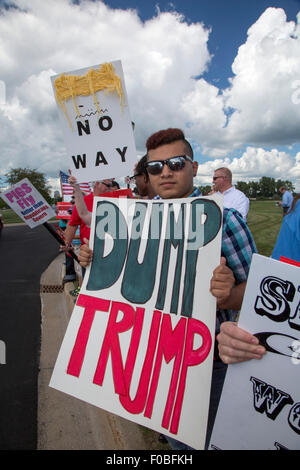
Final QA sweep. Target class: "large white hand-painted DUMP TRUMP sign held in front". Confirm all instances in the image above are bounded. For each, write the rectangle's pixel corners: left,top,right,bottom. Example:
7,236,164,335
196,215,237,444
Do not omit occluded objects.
50,196,222,449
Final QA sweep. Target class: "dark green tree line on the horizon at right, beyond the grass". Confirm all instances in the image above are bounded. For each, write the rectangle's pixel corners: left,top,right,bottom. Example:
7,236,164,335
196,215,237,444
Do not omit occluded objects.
199,176,295,199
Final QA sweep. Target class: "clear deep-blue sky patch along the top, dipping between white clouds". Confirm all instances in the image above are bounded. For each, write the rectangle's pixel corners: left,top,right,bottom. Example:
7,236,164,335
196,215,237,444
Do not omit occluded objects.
104,0,300,88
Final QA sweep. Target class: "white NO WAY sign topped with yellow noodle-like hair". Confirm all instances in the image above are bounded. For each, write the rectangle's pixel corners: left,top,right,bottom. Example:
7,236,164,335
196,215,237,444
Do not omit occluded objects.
51,61,137,183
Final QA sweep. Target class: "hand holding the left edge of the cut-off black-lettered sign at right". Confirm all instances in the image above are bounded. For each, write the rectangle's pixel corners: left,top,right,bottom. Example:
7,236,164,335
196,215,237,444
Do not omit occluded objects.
217,322,266,364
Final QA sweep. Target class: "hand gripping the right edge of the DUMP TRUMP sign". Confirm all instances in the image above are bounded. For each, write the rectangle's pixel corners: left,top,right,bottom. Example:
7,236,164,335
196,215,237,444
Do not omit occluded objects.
210,257,235,307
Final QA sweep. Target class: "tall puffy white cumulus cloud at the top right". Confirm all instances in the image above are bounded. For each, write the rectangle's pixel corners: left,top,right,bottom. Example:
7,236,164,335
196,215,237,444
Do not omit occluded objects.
224,8,300,146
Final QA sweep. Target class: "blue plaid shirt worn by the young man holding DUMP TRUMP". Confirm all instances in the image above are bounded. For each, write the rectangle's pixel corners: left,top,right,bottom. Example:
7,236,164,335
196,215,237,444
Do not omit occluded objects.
153,188,257,334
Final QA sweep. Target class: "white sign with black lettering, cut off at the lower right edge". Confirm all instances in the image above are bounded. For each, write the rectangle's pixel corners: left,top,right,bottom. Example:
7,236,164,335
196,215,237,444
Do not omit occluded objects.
209,255,300,450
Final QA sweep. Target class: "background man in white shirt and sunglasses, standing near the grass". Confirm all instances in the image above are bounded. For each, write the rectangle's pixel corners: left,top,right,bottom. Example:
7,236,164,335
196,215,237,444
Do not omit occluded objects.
213,167,249,220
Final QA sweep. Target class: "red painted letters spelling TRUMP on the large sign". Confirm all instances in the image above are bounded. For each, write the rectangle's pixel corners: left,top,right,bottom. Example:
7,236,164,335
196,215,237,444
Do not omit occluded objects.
67,295,212,434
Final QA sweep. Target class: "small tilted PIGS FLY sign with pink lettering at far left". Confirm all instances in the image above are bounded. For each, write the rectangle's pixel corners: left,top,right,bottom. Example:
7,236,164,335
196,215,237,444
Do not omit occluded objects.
1,178,55,228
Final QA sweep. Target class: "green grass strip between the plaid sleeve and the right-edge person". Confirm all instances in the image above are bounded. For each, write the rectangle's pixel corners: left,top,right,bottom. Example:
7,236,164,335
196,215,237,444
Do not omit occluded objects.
248,201,282,256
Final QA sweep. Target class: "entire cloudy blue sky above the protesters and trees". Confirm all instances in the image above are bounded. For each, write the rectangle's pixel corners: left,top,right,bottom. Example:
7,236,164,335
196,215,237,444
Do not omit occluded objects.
0,0,300,191
